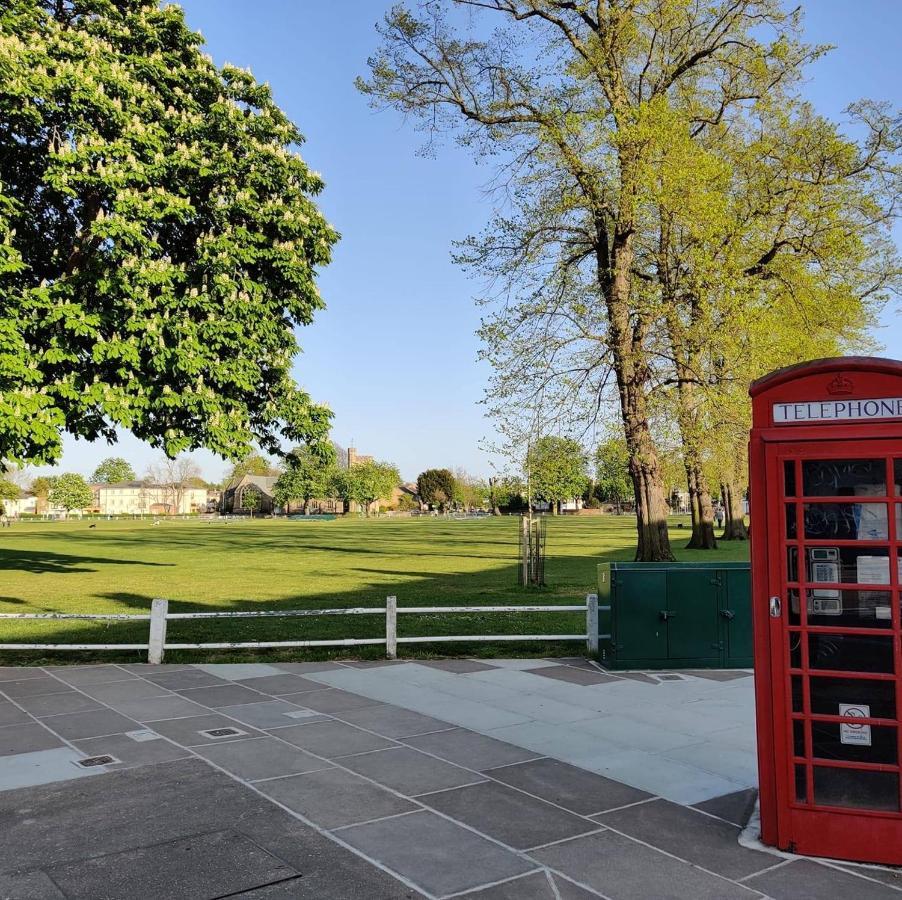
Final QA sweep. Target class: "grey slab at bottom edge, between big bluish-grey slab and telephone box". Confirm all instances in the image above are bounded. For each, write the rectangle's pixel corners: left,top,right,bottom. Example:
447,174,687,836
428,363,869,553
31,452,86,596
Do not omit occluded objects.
530,831,759,900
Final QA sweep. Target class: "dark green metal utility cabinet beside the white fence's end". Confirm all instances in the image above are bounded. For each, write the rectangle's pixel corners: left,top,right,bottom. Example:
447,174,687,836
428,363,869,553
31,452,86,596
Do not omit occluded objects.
598,562,752,669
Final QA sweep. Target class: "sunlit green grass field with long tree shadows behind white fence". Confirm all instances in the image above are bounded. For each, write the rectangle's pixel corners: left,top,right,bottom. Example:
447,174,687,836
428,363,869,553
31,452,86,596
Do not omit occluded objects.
0,516,748,664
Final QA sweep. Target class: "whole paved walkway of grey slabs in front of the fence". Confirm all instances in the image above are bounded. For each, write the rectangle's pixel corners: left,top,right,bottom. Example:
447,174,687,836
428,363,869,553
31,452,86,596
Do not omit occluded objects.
0,659,902,900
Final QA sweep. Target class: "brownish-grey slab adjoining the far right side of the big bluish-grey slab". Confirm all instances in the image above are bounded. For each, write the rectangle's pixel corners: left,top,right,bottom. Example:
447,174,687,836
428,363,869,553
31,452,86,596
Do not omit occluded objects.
421,781,598,850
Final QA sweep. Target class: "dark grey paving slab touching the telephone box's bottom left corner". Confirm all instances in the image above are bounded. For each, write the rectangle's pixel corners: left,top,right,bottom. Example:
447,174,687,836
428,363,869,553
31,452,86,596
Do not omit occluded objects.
595,800,776,878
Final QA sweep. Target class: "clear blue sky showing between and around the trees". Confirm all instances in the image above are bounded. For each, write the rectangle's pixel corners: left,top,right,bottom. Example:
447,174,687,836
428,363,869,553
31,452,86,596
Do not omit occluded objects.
46,0,902,479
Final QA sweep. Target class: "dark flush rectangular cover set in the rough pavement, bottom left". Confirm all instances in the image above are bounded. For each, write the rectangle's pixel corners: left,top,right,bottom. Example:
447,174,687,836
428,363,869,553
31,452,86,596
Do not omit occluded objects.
48,831,299,900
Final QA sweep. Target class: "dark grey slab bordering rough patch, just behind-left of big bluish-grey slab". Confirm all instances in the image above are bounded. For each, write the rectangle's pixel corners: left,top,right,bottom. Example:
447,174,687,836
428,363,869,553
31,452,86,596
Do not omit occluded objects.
256,769,418,828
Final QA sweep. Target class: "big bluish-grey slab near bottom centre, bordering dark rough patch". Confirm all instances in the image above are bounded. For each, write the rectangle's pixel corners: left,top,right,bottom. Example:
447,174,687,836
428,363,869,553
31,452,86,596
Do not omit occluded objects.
341,812,532,896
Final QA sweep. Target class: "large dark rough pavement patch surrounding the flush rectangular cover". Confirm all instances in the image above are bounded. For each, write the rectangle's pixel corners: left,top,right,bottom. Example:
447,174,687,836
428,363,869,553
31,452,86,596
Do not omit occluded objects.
0,759,417,900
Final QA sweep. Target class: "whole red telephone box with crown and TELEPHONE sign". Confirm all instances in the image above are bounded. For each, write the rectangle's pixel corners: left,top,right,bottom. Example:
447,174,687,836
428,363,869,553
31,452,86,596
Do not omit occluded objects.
749,357,902,865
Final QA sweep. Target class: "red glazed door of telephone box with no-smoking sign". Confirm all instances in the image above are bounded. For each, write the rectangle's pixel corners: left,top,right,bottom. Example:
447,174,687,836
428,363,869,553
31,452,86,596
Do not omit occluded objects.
764,439,902,864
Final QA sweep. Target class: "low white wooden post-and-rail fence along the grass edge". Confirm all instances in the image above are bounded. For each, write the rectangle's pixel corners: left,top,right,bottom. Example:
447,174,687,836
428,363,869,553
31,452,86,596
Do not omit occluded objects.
0,594,599,663
